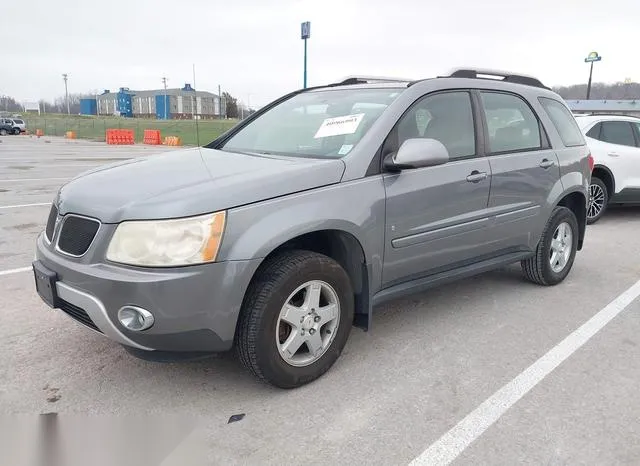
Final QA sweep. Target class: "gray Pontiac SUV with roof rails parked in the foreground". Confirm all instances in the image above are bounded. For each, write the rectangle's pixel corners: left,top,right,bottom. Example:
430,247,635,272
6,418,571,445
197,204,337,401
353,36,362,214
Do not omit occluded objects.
33,69,592,388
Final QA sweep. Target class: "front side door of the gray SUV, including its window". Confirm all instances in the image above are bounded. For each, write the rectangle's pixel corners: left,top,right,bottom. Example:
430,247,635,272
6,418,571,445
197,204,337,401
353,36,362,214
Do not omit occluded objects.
383,91,491,286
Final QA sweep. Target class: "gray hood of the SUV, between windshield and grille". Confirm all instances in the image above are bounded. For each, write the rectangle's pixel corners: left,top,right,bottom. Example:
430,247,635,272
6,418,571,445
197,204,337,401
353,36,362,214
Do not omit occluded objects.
56,148,345,223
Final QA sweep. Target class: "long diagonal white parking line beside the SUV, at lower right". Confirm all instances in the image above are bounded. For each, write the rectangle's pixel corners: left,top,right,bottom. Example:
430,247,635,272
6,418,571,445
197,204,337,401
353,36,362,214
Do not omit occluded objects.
410,280,640,466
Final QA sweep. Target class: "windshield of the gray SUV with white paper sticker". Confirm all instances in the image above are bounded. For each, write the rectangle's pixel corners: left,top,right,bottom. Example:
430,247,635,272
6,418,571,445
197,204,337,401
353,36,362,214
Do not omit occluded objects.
222,88,401,158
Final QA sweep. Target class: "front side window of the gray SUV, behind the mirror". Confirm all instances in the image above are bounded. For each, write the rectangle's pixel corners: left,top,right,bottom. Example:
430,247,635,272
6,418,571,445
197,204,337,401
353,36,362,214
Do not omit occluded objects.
385,91,476,160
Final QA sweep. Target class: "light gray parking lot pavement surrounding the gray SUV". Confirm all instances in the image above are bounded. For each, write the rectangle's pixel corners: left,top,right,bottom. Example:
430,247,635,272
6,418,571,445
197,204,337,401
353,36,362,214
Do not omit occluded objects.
0,136,640,465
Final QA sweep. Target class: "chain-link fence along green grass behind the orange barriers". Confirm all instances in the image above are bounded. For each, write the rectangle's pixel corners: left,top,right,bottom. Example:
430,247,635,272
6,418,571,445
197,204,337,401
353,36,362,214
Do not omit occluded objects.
25,115,237,146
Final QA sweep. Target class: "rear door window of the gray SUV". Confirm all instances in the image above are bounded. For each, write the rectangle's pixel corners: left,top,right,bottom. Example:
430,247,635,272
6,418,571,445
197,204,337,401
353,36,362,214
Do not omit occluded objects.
480,92,542,153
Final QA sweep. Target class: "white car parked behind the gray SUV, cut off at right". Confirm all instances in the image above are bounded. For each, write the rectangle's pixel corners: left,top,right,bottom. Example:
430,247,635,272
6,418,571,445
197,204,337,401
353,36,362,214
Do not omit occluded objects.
576,115,640,224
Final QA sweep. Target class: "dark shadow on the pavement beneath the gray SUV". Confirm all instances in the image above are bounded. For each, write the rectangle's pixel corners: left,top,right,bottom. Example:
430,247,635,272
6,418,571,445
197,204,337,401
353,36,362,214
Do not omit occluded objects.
76,265,528,400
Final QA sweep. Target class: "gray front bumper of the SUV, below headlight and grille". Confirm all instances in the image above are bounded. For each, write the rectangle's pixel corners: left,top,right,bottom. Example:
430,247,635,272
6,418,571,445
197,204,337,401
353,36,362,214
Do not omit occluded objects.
36,234,260,352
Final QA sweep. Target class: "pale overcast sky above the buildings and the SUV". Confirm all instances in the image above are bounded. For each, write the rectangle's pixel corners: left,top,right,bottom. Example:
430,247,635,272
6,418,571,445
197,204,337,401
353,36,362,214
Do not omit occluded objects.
0,0,640,105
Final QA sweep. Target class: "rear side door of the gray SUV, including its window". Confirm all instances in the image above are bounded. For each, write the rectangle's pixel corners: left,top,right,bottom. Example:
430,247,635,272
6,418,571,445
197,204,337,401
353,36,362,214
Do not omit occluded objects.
476,90,560,252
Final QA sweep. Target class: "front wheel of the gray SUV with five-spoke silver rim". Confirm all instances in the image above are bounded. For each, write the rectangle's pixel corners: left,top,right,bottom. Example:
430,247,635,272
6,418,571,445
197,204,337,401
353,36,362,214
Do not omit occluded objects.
236,250,354,388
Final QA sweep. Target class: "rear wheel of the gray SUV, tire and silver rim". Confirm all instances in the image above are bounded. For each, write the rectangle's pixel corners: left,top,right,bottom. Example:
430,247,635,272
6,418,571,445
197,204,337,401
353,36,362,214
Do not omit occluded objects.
521,207,579,286
